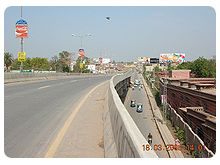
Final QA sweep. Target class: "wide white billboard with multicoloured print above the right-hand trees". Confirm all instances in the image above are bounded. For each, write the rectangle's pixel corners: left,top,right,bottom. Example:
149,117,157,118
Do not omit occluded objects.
160,53,185,64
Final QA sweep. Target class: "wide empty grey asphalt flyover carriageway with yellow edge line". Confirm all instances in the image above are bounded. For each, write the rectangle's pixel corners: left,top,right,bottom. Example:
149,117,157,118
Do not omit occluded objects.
4,76,111,157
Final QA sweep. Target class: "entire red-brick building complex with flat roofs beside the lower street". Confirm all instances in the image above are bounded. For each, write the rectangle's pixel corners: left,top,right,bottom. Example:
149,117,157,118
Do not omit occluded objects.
160,78,216,152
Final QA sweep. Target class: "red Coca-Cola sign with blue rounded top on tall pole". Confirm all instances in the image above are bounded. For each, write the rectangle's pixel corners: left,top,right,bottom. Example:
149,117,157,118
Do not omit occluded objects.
15,19,28,38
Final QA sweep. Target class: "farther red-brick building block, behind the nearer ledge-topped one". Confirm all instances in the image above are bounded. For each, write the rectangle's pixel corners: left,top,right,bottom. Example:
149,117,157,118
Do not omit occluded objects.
160,78,216,116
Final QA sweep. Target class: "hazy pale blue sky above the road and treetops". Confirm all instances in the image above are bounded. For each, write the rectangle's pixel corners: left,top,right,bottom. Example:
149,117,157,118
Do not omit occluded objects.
4,7,216,61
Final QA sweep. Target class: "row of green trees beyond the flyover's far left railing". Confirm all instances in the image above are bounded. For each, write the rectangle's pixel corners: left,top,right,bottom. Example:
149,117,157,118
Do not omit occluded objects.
4,51,90,73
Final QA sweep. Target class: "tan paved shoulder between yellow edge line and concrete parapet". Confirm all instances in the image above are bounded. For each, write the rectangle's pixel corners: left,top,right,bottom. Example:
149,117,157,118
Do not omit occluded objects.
50,81,109,158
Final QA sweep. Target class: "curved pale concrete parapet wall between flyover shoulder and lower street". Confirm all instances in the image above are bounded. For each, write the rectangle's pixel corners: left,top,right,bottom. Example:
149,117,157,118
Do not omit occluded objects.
104,75,158,158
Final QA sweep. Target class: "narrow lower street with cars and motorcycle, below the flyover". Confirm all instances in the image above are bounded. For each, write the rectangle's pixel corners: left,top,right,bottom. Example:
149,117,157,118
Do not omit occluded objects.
124,72,169,158
